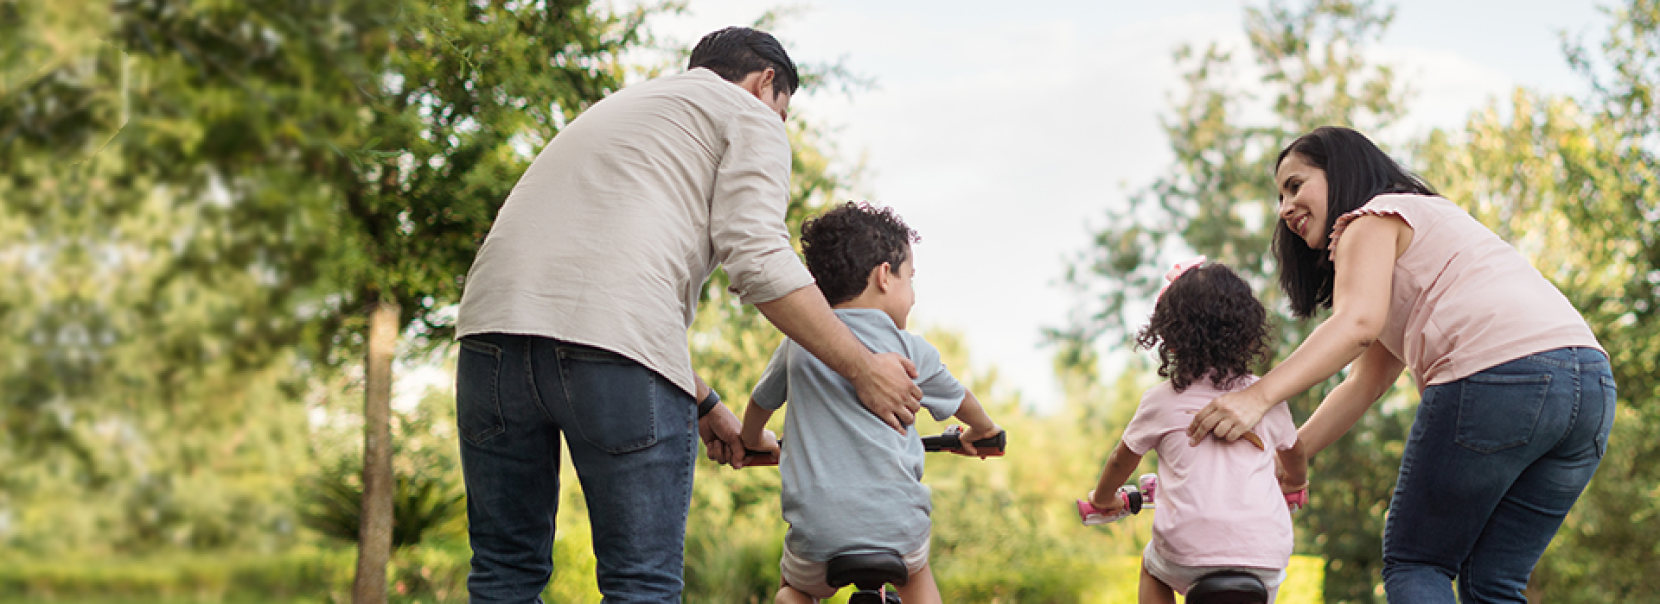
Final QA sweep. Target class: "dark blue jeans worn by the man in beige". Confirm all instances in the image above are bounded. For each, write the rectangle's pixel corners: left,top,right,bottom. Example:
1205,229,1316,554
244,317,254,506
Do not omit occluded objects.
455,334,697,602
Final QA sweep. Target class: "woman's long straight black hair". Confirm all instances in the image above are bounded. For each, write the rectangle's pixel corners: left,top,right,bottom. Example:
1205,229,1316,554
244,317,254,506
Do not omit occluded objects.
1273,126,1436,319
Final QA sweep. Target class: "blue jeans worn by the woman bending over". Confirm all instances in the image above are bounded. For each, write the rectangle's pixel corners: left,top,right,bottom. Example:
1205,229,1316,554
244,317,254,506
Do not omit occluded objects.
1383,348,1615,604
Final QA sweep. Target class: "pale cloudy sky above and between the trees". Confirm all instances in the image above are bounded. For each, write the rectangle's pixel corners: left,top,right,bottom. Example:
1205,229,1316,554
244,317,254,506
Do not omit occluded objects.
614,0,1607,408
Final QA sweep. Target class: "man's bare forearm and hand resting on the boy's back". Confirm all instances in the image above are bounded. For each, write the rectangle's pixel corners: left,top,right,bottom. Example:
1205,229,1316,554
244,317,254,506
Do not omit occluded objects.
755,284,923,435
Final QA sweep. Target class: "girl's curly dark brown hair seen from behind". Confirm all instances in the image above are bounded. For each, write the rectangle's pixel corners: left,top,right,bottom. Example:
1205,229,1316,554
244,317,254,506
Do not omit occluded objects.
1135,262,1268,392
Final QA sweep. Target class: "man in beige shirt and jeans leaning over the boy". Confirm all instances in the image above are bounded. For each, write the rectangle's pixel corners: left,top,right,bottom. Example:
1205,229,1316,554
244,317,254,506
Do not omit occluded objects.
457,28,921,602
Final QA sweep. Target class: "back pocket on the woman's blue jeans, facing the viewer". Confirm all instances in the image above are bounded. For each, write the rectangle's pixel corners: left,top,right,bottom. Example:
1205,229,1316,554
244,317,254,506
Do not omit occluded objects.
1456,372,1550,453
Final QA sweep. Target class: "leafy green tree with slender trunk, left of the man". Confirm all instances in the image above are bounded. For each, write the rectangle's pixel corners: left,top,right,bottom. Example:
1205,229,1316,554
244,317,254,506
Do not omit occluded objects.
0,0,660,601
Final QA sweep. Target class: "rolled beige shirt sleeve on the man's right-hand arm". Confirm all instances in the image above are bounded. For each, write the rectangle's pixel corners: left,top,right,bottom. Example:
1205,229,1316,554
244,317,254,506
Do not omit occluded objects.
709,101,813,304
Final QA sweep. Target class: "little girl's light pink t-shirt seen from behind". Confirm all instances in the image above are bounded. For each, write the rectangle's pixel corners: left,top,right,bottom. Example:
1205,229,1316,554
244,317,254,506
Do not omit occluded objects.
1124,377,1296,569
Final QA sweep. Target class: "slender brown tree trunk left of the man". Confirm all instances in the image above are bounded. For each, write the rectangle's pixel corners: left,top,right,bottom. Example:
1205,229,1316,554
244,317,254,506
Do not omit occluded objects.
352,294,398,604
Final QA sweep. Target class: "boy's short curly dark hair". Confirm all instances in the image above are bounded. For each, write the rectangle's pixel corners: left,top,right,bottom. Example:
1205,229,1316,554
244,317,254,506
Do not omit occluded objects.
802,201,921,305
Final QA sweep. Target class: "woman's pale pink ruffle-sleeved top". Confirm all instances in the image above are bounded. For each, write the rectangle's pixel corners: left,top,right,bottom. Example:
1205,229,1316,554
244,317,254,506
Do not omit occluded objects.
1328,194,1602,390
